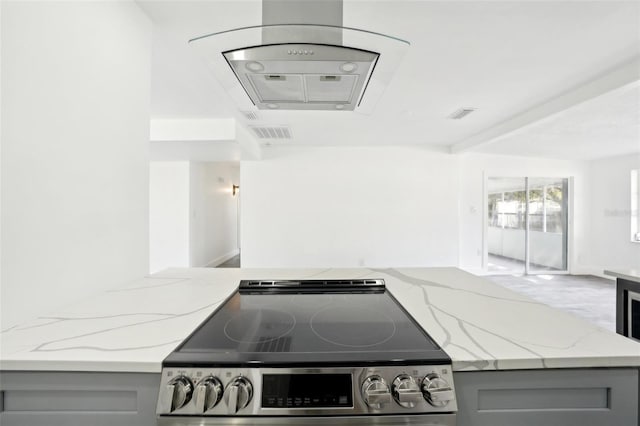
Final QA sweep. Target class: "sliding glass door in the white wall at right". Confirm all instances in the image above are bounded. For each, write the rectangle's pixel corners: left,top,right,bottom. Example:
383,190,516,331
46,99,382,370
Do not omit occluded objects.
485,177,568,274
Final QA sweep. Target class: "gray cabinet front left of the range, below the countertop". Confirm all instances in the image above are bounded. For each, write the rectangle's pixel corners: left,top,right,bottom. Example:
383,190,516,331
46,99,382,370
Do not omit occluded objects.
0,371,160,426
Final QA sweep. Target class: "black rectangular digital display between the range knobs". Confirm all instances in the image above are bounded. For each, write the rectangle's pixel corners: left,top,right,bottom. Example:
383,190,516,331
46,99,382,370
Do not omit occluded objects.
262,374,353,408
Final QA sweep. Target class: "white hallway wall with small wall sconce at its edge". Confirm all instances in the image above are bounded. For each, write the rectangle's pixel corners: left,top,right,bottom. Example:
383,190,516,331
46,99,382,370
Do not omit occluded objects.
190,162,240,266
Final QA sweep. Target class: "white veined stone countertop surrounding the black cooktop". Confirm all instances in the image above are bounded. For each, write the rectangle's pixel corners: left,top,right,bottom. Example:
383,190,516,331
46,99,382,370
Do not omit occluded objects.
0,268,640,373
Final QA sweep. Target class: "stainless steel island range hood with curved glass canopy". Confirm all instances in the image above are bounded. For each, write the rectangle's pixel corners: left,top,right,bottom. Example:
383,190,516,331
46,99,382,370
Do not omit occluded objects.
190,0,409,113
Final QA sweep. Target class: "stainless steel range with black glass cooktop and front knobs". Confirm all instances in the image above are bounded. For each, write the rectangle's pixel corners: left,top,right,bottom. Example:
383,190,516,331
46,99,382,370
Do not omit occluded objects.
157,279,457,426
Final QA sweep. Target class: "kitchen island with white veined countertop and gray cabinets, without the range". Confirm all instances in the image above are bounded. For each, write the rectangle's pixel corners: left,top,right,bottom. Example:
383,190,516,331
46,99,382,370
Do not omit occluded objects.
0,268,640,426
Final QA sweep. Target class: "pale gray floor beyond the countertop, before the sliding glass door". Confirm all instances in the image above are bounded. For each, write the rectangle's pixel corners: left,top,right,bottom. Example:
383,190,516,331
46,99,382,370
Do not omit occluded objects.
485,275,616,332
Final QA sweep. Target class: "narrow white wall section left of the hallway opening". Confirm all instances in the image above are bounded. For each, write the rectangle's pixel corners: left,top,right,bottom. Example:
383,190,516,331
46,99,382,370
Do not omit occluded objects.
149,161,190,273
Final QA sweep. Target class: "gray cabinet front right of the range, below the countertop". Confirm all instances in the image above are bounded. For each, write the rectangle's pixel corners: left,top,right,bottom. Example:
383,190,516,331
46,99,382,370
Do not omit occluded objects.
455,368,640,426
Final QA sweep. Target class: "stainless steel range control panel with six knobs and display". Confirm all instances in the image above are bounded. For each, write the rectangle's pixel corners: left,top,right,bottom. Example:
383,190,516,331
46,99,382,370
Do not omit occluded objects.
157,365,457,416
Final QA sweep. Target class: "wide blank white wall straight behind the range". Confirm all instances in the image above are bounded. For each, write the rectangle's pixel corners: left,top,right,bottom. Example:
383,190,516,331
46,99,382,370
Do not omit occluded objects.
241,147,458,267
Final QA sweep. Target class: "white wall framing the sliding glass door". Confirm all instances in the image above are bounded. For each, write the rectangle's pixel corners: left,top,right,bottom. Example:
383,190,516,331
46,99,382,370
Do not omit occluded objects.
459,153,590,273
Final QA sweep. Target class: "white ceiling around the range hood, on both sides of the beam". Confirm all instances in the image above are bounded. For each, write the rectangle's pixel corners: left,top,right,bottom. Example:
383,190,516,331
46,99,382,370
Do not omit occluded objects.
139,0,640,159
